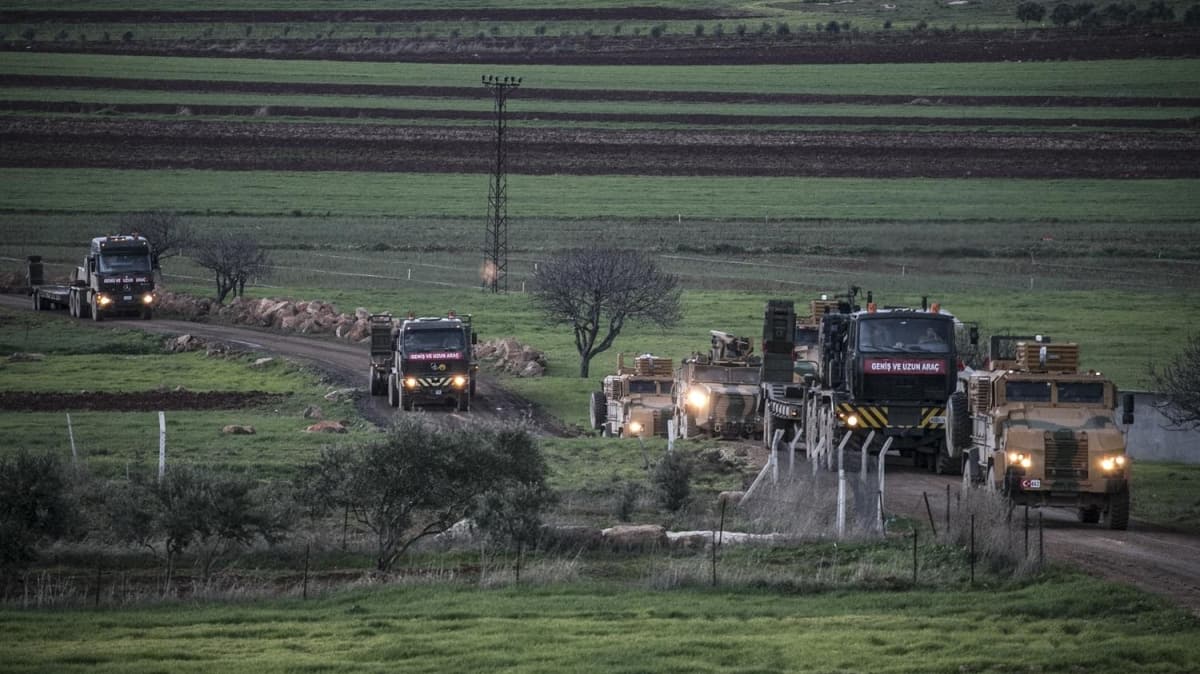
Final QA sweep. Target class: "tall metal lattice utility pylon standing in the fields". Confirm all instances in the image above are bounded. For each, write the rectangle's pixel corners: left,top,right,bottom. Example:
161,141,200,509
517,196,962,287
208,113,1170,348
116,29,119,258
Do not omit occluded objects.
480,74,521,293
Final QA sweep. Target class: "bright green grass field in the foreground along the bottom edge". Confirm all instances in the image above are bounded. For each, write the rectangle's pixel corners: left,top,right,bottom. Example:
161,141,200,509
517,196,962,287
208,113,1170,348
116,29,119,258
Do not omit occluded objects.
0,574,1200,673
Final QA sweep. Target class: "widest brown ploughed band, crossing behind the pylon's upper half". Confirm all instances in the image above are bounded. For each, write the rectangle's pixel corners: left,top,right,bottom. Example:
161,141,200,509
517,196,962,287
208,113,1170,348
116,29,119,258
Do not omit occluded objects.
0,115,1200,179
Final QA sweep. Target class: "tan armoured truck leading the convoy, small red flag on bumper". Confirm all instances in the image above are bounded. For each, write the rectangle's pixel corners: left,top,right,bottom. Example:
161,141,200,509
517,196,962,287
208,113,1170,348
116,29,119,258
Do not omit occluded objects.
952,336,1133,529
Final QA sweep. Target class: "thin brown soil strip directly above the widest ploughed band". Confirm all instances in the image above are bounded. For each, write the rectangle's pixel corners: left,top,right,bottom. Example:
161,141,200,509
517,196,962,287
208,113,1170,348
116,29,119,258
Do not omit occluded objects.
0,101,1200,130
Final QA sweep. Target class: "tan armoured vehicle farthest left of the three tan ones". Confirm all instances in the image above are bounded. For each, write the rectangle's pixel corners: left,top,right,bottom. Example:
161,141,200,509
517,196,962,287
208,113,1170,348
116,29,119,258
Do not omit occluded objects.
588,354,674,438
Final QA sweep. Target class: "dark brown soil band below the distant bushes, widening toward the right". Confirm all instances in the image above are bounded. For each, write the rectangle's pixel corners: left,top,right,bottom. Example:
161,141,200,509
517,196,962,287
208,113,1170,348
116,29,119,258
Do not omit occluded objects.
9,26,1200,66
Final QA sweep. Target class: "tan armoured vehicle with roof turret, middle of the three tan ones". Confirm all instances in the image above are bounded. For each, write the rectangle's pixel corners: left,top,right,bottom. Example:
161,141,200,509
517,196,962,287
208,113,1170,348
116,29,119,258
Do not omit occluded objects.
674,330,762,438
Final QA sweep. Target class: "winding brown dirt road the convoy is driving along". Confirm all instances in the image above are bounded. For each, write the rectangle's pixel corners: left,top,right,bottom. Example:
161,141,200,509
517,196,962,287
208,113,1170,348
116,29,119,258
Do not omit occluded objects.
0,295,1200,615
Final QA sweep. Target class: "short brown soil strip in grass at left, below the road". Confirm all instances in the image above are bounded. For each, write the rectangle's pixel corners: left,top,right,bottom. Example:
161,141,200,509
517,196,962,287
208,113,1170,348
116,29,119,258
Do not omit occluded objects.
0,391,288,411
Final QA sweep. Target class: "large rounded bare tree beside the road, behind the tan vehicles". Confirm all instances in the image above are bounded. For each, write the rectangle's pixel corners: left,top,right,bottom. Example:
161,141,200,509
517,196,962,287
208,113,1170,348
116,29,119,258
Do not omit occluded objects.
533,248,680,377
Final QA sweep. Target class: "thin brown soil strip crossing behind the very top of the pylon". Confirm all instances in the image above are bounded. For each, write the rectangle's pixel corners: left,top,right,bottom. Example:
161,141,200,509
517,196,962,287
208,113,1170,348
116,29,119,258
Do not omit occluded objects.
0,74,1200,108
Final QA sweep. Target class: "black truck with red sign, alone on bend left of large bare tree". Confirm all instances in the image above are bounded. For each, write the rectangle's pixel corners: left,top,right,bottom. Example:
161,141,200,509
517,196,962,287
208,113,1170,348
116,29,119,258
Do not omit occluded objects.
367,311,479,411
